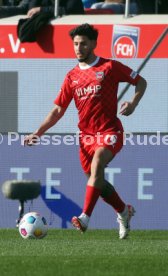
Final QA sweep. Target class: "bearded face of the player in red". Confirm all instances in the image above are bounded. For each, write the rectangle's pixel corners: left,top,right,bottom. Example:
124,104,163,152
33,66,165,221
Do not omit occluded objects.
73,35,96,62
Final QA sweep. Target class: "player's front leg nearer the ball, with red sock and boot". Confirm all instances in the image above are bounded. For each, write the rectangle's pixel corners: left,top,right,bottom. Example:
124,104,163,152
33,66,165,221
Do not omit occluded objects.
72,147,113,232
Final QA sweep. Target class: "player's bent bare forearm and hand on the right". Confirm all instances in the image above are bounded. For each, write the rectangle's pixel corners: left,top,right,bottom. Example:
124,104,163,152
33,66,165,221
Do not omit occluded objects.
120,77,147,116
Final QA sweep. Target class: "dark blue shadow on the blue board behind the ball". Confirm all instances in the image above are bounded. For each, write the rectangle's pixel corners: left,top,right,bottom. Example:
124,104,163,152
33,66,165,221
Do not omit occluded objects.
41,186,82,228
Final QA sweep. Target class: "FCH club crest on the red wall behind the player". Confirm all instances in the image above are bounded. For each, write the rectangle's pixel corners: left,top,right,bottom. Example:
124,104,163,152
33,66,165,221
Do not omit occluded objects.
112,25,139,58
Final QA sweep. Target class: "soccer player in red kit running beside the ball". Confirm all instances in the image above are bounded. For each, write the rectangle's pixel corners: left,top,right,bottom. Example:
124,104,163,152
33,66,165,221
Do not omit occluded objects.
25,23,146,239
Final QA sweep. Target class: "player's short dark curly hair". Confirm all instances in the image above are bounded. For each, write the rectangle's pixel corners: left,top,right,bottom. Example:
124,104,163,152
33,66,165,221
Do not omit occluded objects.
69,23,98,41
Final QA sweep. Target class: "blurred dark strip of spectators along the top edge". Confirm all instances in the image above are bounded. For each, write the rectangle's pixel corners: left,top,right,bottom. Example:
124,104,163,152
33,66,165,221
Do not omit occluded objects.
0,0,168,18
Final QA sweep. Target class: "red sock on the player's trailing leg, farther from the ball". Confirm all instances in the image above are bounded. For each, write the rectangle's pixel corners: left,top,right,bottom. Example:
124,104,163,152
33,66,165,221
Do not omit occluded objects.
103,191,125,213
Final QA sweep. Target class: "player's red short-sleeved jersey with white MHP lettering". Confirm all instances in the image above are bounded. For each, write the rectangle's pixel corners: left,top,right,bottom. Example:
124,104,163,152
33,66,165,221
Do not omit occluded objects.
54,58,140,135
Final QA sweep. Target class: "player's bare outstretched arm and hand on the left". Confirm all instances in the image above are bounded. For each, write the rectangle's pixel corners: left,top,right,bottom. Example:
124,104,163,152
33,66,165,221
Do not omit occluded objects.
24,105,66,146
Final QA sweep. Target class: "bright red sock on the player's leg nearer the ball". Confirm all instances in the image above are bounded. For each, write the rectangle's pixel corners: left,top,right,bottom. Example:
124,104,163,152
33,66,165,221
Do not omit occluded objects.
83,185,101,217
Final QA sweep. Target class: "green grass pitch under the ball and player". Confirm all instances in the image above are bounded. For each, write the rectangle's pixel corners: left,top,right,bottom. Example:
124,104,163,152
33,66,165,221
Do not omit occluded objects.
0,229,168,276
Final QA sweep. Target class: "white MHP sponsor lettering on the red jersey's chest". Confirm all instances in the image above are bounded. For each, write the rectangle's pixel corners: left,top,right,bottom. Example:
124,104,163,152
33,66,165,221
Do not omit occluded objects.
75,84,101,99
